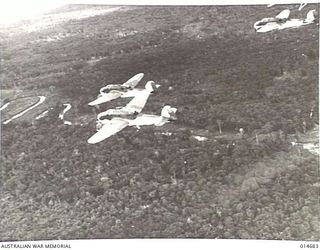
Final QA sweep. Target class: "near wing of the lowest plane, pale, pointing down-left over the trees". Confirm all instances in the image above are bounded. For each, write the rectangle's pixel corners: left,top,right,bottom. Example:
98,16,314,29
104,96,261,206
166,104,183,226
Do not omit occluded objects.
88,118,129,144
